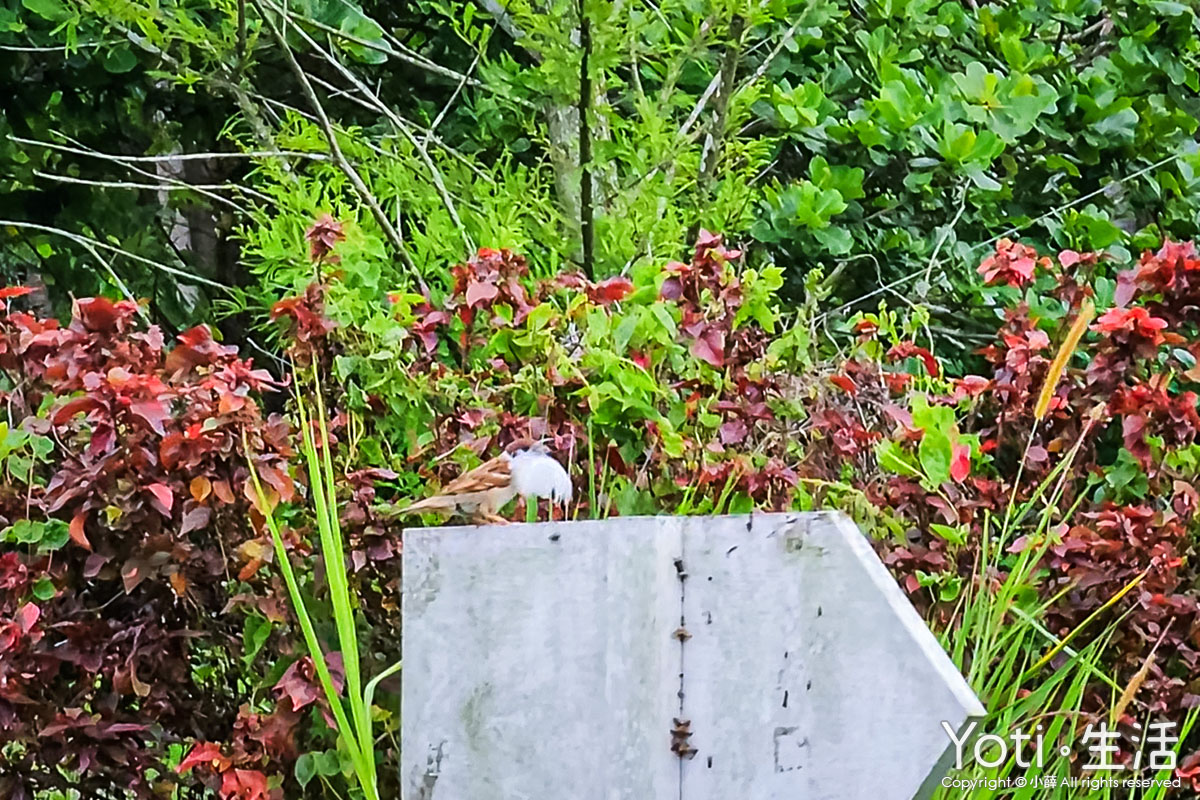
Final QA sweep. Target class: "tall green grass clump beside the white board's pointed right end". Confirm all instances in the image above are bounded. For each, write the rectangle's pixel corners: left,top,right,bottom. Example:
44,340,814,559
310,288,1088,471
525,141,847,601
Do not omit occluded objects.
934,438,1198,800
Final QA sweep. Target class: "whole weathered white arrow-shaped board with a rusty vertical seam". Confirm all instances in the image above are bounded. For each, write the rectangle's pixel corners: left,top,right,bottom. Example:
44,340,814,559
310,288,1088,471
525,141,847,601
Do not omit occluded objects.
402,513,983,800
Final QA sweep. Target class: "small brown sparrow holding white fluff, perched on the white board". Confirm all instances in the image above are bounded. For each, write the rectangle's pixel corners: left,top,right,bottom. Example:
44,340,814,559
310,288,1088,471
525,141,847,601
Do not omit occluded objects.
400,439,571,524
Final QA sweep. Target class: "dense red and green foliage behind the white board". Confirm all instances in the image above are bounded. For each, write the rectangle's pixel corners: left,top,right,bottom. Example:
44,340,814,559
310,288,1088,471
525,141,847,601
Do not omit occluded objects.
0,0,1200,800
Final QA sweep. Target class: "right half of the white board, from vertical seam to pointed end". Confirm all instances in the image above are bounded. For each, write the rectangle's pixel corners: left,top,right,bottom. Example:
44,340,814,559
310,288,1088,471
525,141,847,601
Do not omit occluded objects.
683,515,983,800
